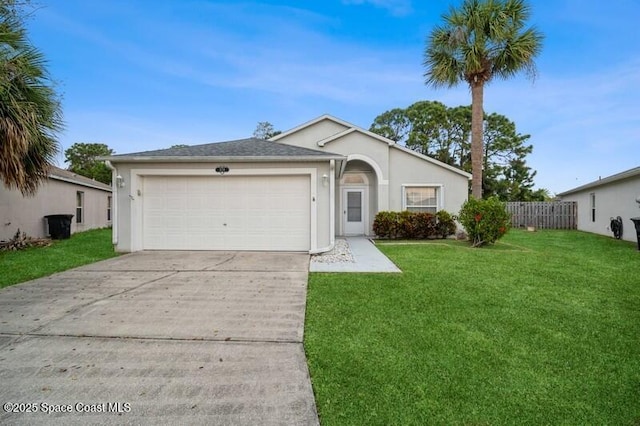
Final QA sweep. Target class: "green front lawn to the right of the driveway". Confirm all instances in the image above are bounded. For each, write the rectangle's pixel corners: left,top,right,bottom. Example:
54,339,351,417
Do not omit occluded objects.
305,230,640,425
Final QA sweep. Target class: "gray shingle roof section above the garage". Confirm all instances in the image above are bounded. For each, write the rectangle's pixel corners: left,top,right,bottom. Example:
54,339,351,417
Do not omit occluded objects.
109,138,341,161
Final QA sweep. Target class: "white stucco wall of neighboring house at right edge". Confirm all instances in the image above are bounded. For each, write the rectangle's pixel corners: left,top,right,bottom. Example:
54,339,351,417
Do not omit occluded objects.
562,176,640,242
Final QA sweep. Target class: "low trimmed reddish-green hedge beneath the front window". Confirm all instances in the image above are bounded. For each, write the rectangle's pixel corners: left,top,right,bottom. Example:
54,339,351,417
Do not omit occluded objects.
373,211,456,239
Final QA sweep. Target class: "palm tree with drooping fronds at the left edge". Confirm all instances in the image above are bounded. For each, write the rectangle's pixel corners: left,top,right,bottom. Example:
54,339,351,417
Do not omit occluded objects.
0,0,63,195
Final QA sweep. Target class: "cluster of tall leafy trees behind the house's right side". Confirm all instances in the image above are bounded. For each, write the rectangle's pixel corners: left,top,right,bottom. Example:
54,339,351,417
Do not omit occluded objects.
370,101,544,201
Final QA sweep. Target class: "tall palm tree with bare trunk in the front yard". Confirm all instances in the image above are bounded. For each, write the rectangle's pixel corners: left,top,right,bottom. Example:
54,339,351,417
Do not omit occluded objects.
424,0,543,198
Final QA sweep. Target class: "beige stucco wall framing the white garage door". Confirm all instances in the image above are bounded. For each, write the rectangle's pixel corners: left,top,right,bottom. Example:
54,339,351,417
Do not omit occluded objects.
113,160,333,252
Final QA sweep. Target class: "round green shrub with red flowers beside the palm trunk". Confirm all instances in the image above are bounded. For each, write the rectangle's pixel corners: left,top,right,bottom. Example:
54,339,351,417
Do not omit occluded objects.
460,197,511,247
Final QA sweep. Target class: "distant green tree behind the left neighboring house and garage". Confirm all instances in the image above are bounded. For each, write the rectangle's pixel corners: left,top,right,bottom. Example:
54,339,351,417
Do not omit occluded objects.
64,143,113,185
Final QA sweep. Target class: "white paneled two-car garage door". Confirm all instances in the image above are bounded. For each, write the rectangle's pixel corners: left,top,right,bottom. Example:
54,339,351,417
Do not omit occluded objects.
142,176,310,251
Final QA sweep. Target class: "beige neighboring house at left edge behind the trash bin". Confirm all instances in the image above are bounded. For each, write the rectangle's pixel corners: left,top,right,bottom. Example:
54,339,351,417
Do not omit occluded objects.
0,167,112,240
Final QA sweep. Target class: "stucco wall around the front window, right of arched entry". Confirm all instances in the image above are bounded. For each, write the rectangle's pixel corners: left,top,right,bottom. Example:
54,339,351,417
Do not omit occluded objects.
389,149,469,214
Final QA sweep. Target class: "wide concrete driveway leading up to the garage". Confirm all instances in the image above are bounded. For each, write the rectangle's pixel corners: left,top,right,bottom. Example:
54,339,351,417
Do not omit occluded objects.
0,252,318,425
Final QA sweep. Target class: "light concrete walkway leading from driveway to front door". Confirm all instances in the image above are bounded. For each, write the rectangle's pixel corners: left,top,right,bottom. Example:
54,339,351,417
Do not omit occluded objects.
309,237,402,272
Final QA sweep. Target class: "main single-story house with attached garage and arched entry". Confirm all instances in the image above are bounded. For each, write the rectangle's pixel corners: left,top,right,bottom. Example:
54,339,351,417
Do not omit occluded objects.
106,115,471,253
